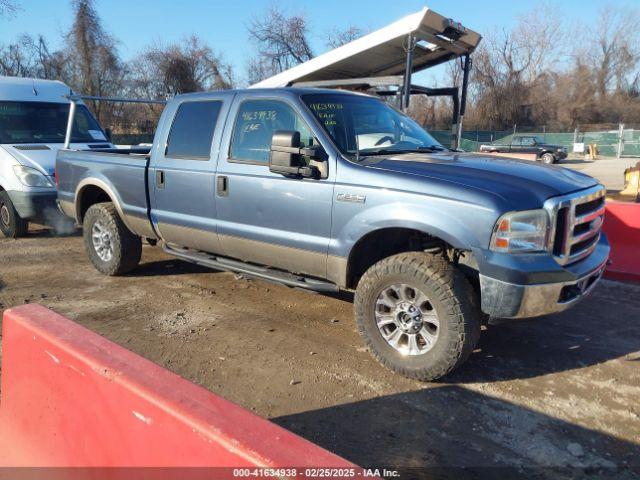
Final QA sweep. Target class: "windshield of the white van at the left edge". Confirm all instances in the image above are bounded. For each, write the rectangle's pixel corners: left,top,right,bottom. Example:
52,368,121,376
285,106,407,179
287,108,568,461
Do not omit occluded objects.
0,101,107,143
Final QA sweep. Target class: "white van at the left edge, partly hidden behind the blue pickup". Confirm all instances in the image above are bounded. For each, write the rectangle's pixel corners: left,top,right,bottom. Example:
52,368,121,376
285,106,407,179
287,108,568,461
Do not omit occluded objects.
0,77,111,238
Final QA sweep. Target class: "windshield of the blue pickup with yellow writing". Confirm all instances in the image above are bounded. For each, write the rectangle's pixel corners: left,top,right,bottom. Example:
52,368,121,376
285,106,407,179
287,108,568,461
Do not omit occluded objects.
302,94,444,156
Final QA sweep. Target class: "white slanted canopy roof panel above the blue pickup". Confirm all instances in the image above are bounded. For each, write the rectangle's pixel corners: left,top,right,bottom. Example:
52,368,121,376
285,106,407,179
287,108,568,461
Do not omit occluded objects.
251,7,481,88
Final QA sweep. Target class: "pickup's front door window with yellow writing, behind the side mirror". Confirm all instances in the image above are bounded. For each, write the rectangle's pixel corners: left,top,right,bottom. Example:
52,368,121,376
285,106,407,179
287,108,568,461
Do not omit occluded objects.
229,100,313,164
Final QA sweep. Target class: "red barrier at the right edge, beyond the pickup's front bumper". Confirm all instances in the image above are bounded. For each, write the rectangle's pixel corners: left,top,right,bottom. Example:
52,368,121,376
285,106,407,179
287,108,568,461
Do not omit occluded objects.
603,201,640,282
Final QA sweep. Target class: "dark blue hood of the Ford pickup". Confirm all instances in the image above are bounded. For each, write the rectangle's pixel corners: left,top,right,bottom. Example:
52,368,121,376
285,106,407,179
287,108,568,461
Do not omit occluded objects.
360,152,598,206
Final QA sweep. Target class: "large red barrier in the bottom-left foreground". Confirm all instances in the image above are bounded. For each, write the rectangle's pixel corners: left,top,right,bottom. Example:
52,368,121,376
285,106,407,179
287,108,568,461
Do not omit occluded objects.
0,305,353,472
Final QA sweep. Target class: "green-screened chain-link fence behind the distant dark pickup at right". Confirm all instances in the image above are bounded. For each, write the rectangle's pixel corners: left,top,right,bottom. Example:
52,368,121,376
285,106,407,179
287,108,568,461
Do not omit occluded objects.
430,124,640,158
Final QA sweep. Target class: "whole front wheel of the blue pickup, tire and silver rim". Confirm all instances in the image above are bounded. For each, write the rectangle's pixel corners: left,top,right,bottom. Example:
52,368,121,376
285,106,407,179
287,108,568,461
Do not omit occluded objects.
355,252,480,381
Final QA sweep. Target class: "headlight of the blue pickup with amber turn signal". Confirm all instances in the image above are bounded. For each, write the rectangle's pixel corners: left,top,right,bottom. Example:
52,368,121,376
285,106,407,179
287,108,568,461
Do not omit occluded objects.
490,210,549,253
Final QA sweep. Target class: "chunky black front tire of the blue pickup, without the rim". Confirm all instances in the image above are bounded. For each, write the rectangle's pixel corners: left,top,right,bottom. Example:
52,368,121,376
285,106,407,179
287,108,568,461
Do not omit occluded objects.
354,252,480,381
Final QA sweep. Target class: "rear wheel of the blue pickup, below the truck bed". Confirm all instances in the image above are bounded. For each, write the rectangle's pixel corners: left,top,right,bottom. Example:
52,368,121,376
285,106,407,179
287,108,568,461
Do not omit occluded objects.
82,202,142,276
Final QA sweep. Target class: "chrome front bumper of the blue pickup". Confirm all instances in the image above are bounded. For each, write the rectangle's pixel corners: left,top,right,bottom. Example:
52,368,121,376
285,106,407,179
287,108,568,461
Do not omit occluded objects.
480,238,609,318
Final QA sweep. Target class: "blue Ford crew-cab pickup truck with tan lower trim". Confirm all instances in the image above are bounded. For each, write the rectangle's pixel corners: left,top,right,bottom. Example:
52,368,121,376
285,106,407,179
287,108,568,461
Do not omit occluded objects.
57,88,609,380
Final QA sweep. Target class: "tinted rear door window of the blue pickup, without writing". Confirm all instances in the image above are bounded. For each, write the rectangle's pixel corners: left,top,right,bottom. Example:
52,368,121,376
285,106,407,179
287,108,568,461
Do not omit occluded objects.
165,101,222,160
